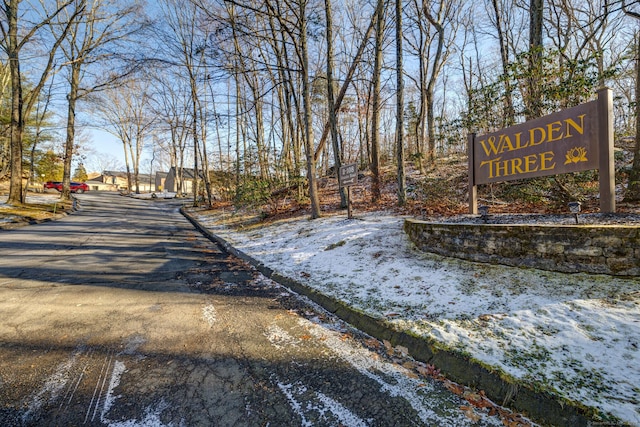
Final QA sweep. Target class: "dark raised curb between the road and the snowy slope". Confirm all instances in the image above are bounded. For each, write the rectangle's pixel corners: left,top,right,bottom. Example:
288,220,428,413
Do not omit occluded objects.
180,208,604,427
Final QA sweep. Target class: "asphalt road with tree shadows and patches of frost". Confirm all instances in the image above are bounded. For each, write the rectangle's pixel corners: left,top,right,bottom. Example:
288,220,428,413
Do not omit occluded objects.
0,193,502,427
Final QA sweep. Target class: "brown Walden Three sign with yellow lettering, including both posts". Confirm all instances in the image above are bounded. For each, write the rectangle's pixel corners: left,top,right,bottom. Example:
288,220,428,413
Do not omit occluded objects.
469,88,615,214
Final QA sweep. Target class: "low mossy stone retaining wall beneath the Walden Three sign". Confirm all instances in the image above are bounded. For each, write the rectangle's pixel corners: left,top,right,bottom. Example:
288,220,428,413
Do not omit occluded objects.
404,219,640,276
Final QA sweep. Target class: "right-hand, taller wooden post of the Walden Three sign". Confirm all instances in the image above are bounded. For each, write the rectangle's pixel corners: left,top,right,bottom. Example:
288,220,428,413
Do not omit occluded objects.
598,87,616,213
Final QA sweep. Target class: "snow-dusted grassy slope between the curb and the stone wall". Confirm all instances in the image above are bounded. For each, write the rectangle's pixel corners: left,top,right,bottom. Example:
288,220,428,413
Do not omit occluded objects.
196,213,640,425
